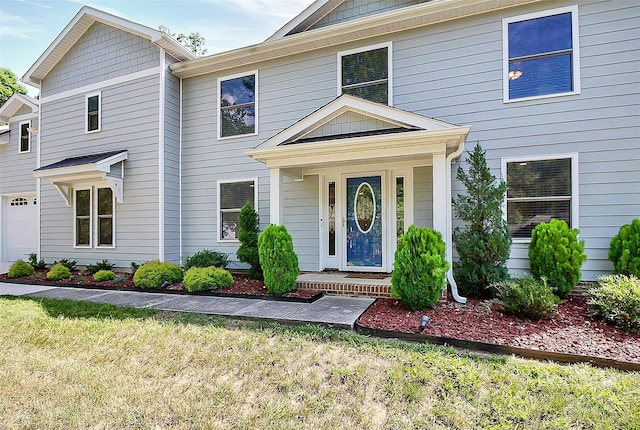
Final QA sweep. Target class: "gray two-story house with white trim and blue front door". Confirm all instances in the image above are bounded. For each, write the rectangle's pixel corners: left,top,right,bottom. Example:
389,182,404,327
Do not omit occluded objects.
0,0,640,296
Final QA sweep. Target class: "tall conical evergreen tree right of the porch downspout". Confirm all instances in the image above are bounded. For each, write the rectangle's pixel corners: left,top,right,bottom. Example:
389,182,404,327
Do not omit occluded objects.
453,144,511,298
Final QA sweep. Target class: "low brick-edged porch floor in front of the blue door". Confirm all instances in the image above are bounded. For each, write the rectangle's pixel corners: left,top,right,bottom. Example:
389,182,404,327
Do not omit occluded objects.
297,272,391,298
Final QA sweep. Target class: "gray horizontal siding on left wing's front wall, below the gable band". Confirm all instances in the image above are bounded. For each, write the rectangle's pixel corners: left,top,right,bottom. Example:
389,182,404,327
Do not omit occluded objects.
40,76,160,267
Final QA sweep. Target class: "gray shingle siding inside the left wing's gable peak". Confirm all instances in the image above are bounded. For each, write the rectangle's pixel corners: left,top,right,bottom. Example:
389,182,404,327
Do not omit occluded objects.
41,22,160,97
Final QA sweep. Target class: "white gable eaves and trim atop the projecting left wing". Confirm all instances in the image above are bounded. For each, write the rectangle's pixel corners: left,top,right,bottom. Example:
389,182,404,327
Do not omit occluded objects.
21,6,197,88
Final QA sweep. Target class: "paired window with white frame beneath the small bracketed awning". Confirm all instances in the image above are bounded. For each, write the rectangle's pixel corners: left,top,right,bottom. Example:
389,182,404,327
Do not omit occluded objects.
74,187,115,248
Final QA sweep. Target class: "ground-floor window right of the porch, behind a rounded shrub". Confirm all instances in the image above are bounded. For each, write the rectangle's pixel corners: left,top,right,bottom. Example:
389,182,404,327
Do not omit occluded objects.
503,156,578,240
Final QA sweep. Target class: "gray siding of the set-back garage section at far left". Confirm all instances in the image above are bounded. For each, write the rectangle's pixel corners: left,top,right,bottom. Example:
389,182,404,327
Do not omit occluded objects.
0,116,38,195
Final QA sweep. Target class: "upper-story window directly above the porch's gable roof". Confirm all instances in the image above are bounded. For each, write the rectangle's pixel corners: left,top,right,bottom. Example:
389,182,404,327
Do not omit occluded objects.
338,42,393,105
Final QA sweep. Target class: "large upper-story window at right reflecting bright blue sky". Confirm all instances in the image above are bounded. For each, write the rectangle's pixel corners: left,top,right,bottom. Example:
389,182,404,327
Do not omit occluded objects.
502,6,580,102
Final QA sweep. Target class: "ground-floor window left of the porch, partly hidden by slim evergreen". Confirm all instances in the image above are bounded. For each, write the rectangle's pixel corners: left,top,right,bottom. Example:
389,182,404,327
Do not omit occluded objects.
218,179,257,241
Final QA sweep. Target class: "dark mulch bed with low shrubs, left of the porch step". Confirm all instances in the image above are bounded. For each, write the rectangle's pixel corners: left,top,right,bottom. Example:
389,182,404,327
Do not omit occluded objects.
0,270,321,301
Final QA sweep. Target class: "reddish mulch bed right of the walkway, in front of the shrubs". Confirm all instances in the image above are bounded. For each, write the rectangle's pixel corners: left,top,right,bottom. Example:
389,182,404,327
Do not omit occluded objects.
358,296,640,363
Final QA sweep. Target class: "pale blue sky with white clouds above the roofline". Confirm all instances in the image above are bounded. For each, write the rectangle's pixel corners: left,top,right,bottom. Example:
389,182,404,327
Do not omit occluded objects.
0,0,314,96
